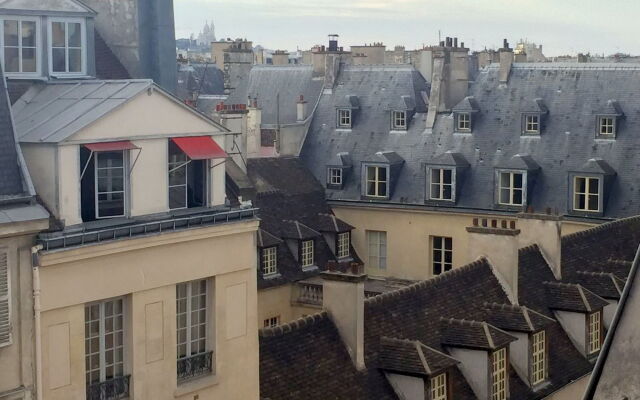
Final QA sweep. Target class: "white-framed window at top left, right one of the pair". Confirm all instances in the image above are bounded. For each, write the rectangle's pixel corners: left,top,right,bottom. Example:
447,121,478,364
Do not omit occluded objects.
49,19,86,74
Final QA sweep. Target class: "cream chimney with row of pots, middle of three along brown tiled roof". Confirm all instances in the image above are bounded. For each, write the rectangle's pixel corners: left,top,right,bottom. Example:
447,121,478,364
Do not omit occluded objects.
467,218,520,304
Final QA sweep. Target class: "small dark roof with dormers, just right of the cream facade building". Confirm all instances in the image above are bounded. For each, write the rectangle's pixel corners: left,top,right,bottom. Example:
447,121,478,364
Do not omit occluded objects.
247,157,360,289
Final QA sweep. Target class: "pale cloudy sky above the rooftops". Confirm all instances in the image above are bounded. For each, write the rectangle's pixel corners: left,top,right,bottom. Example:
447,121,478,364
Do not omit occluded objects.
174,0,640,56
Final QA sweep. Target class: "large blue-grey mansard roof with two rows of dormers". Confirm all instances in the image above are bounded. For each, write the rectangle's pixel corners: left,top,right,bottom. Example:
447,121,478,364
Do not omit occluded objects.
301,64,640,218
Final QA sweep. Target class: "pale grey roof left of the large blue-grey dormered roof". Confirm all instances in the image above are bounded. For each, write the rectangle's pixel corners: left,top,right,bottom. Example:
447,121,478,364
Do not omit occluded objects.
227,65,324,125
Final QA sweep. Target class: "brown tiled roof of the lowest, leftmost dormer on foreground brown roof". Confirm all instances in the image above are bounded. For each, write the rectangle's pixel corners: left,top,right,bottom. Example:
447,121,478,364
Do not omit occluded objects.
379,336,459,377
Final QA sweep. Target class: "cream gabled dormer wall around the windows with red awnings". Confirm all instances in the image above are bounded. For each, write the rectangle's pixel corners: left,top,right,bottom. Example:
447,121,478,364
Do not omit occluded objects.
23,90,232,225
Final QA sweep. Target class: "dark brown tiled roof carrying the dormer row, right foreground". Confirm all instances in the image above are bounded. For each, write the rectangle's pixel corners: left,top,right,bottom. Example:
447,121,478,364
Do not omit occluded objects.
260,218,640,400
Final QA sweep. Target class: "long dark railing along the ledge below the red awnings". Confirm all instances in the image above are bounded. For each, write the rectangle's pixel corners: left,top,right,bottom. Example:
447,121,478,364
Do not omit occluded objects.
38,208,258,250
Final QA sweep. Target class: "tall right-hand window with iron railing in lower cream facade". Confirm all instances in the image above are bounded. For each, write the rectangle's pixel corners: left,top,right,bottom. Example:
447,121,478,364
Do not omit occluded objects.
176,279,212,379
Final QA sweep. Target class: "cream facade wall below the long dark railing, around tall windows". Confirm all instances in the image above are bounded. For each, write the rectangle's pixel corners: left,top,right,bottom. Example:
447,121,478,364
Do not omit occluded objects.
39,221,259,400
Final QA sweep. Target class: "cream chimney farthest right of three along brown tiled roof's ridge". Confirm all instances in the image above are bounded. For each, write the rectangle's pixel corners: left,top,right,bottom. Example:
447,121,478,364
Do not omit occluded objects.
517,209,562,280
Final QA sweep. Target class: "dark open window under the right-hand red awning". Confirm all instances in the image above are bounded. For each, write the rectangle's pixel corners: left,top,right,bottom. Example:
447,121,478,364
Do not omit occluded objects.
168,140,207,210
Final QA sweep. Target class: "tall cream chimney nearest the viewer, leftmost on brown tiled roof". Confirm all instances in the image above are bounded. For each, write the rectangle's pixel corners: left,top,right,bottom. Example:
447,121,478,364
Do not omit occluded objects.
321,263,367,370
